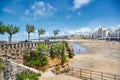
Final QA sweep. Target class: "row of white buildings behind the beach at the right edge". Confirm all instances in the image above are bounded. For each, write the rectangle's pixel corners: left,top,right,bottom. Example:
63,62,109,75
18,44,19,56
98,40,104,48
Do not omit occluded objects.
91,27,120,41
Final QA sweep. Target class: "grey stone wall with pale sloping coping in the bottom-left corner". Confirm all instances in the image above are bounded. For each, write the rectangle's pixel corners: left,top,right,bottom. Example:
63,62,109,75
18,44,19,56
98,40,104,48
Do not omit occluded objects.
0,59,39,80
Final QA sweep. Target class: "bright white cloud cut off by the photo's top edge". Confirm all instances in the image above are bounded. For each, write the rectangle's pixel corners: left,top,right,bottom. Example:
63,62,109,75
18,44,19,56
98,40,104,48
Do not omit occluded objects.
73,0,91,9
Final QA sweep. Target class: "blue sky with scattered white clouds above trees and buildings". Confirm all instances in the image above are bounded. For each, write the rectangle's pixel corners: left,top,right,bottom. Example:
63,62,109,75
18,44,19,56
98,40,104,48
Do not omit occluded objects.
0,0,120,41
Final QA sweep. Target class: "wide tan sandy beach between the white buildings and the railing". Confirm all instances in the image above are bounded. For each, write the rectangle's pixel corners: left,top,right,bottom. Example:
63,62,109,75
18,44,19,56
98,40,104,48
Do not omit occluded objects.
71,40,120,75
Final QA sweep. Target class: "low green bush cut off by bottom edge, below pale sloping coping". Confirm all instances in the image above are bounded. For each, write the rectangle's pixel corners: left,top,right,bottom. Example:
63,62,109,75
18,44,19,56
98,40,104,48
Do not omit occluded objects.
16,72,40,80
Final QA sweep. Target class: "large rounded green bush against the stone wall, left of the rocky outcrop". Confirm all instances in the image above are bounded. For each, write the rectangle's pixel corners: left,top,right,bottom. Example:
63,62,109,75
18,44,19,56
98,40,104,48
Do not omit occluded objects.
23,43,49,67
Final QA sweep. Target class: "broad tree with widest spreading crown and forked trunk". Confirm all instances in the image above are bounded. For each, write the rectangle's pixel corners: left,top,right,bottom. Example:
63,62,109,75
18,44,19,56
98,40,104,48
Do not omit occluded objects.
5,25,20,42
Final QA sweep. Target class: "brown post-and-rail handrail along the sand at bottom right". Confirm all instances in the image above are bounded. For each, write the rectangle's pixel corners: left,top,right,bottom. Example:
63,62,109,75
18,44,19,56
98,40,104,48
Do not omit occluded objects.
70,67,120,80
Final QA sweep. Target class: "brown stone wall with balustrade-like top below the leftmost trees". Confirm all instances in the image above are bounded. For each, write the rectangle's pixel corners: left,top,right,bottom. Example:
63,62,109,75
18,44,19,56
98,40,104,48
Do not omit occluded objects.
0,42,39,63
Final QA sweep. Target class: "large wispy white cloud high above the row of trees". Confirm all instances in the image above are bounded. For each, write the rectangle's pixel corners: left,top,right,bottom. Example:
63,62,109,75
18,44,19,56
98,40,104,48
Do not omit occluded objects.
25,1,56,19
